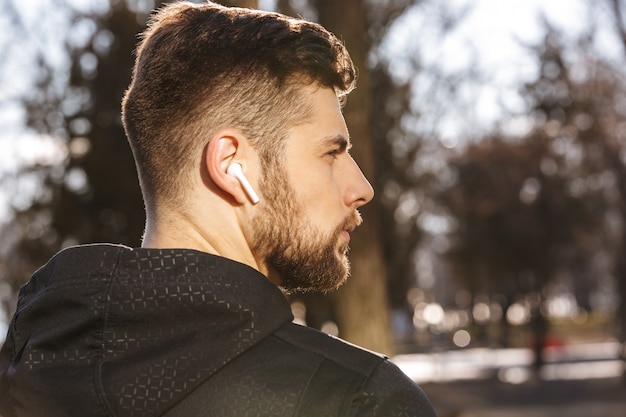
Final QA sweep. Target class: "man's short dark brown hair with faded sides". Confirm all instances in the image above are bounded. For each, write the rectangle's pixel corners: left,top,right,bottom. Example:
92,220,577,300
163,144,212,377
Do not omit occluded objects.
122,2,356,210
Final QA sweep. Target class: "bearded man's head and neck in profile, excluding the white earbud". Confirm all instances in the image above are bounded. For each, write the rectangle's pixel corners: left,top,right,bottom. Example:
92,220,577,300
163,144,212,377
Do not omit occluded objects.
123,3,373,290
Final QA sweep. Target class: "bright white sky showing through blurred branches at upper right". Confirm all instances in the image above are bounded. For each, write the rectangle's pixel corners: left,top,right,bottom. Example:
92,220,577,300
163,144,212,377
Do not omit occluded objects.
385,0,624,142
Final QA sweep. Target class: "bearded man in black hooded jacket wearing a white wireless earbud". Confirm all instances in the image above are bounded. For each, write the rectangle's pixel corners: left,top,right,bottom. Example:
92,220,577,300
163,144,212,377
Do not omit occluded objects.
0,3,434,417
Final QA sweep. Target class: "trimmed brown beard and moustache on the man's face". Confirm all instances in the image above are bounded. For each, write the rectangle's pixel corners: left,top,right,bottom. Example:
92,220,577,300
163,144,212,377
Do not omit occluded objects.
252,162,362,292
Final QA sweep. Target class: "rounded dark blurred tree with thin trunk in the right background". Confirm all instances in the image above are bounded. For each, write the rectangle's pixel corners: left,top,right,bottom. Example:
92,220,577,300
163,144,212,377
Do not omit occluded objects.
441,134,603,367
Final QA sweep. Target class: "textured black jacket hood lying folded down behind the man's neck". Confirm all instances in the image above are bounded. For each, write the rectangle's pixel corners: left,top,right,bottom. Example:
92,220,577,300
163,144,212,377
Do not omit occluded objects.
0,245,293,417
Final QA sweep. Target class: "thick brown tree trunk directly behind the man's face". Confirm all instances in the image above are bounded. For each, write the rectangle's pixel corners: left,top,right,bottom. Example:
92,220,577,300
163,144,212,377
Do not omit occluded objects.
313,0,393,355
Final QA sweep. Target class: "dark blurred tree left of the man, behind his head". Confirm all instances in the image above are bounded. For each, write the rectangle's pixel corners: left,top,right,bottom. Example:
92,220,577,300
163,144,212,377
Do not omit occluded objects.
0,0,178,311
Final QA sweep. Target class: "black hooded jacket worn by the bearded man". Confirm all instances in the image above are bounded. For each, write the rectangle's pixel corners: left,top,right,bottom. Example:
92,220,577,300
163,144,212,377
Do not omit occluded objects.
0,245,434,417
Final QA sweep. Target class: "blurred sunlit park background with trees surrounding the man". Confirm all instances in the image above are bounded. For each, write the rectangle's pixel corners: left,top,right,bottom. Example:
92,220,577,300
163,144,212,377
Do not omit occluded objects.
0,0,626,417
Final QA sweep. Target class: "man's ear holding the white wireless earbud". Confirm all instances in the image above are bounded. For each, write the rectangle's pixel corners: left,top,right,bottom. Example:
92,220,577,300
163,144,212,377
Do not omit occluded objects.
205,129,248,204
